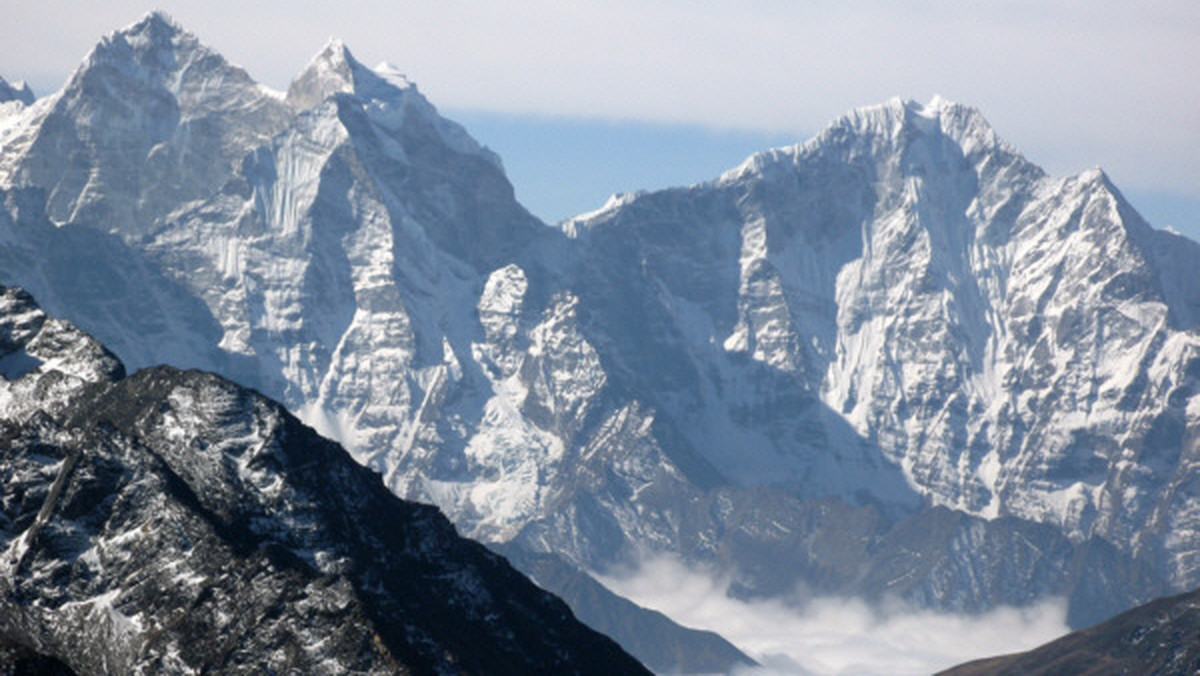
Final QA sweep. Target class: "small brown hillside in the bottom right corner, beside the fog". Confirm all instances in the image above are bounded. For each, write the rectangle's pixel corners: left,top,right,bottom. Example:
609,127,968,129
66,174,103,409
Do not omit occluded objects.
941,591,1200,676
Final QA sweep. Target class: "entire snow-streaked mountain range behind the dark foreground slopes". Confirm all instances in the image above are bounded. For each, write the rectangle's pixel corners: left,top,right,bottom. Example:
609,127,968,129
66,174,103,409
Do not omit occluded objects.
0,14,1200,668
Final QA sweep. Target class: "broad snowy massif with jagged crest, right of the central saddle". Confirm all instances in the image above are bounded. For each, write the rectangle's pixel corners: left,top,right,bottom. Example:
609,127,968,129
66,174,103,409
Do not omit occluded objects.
566,101,1200,585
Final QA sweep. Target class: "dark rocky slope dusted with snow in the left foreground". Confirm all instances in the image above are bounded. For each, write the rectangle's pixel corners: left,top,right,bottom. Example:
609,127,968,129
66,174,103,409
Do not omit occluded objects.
0,289,644,674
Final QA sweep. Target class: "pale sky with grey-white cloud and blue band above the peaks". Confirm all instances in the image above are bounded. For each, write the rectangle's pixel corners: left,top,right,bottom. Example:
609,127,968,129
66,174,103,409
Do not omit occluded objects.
0,0,1200,239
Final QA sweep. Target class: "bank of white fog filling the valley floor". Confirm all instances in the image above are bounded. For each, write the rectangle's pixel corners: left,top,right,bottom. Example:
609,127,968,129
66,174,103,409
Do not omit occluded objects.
598,557,1069,676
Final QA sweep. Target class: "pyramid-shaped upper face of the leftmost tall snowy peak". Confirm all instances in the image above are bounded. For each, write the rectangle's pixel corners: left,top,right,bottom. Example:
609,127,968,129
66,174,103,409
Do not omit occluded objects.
0,14,287,239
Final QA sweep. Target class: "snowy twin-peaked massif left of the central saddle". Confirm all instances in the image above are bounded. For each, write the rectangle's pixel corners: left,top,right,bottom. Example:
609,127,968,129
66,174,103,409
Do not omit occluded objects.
0,13,748,668
